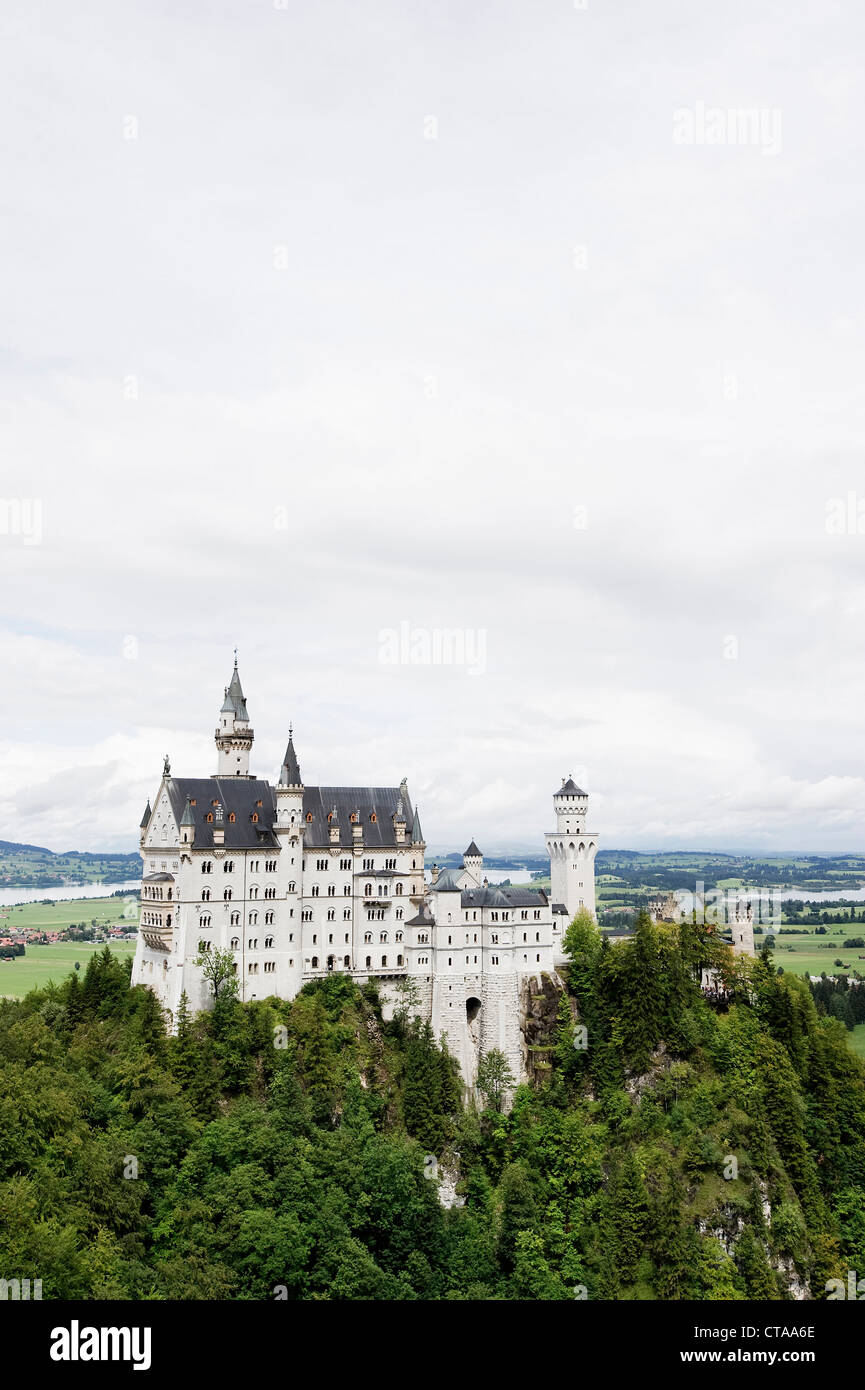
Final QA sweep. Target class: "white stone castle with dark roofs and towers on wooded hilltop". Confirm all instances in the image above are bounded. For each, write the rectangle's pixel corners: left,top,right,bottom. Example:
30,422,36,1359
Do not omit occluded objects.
132,656,598,1084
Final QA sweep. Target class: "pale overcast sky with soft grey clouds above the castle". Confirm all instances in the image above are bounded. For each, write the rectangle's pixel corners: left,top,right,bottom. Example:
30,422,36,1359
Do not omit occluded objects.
0,0,865,851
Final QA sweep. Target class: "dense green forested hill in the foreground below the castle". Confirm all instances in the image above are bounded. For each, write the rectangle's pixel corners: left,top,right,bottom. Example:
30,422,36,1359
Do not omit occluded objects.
0,917,865,1300
